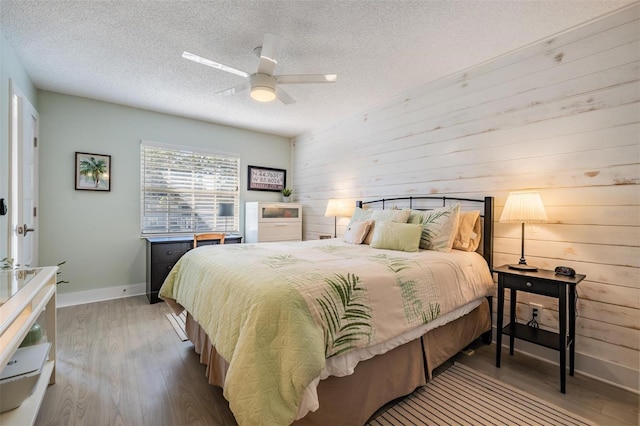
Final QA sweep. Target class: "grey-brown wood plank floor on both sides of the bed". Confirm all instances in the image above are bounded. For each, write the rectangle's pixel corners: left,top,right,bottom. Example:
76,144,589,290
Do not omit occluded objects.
36,296,639,426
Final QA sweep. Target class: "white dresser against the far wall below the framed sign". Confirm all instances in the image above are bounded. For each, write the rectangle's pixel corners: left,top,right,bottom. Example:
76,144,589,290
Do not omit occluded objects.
244,201,302,243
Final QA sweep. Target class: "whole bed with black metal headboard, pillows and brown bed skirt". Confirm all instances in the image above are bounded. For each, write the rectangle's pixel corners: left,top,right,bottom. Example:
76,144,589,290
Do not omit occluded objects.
160,197,494,425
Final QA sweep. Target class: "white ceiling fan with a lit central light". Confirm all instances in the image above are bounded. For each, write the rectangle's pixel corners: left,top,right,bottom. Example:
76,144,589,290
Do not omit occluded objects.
182,33,338,105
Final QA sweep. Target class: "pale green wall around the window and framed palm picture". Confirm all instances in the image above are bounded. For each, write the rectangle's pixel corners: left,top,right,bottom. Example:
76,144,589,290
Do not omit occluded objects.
38,91,291,293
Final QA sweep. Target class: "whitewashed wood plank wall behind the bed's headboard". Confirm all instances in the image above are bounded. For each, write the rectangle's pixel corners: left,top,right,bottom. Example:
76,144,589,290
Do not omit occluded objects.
293,4,640,390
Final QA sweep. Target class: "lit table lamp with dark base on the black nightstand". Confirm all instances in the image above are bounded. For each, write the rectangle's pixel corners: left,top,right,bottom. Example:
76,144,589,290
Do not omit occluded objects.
500,191,547,272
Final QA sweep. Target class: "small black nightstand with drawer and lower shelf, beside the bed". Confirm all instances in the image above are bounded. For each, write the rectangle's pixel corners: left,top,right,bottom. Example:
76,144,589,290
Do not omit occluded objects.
493,265,585,393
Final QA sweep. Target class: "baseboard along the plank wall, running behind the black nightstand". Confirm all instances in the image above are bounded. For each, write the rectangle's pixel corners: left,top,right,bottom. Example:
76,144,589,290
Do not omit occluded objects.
493,332,640,394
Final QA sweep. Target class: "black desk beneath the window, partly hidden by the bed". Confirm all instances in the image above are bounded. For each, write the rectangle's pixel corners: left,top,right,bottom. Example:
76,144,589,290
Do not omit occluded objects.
147,234,242,303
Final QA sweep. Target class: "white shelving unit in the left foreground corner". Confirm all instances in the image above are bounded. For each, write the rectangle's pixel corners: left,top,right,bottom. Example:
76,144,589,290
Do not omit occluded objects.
0,266,58,425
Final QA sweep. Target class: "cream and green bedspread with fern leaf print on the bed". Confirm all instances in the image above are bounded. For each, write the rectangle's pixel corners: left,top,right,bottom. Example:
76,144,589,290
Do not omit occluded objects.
160,240,493,425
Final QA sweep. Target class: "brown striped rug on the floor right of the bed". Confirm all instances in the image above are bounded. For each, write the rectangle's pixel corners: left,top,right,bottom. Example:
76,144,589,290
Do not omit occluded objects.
367,363,595,426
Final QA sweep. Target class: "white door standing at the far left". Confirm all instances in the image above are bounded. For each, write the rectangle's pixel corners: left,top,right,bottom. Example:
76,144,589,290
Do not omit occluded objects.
9,82,38,267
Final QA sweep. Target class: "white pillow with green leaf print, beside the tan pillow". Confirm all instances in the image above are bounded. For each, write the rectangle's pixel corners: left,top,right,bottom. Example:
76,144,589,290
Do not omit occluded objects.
413,204,460,253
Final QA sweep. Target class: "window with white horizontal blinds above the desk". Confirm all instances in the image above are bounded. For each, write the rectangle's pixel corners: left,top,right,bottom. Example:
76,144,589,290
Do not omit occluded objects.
140,141,240,235
